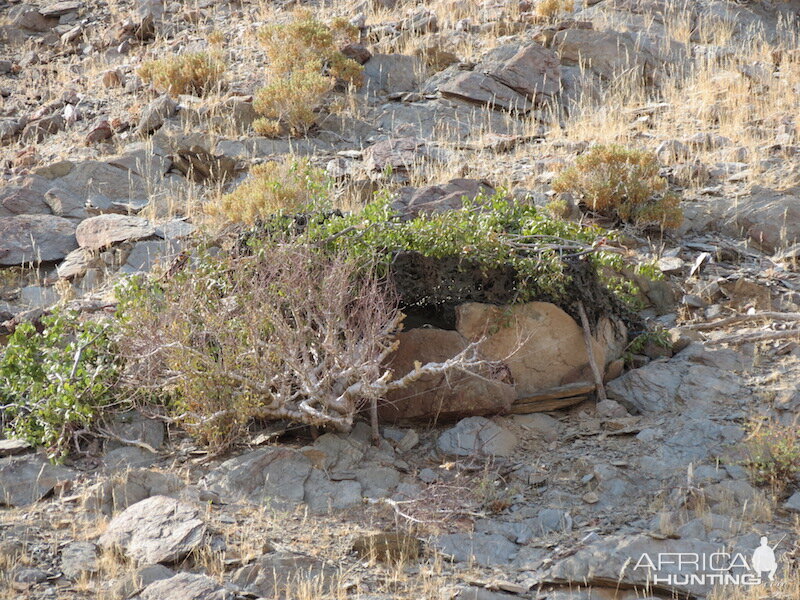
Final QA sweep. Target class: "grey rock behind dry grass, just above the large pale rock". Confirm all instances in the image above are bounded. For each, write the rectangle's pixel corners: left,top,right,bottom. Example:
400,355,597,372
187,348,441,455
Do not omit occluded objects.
83,469,184,515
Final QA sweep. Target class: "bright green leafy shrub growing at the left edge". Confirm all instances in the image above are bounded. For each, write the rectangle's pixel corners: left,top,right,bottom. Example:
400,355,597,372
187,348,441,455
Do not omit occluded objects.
0,314,118,457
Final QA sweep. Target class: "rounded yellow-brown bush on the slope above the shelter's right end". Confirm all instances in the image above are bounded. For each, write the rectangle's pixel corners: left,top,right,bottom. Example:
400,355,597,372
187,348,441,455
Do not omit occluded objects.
553,145,683,229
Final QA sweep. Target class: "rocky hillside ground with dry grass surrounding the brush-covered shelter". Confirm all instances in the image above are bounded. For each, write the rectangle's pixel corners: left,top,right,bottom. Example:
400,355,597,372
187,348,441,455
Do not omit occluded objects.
0,0,800,600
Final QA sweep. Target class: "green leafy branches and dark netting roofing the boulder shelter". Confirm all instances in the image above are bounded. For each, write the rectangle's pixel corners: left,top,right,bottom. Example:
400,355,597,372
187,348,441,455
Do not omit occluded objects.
248,193,638,324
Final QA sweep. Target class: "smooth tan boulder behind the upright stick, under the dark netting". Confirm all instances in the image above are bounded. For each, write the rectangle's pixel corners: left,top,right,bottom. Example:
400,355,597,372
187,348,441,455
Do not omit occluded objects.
456,302,624,398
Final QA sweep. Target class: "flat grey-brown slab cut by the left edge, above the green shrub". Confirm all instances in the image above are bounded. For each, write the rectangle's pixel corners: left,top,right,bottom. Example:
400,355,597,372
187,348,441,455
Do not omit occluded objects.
0,215,78,266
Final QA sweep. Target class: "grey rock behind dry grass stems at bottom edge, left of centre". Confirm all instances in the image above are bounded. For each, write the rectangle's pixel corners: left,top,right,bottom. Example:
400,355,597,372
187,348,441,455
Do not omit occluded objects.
231,552,336,598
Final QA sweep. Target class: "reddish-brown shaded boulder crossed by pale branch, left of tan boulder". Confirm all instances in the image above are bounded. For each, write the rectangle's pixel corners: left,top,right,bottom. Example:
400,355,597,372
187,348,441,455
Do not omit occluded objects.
380,328,516,422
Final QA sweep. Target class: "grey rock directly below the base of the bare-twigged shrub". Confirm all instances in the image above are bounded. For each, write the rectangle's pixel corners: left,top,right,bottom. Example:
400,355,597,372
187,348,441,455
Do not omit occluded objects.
202,447,311,505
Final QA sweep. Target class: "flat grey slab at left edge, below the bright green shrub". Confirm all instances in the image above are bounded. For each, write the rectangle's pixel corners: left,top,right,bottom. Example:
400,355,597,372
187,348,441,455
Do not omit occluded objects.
0,456,75,506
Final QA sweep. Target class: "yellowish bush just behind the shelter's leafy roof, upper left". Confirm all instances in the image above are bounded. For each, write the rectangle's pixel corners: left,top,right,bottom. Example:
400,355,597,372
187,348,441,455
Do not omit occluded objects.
208,159,330,223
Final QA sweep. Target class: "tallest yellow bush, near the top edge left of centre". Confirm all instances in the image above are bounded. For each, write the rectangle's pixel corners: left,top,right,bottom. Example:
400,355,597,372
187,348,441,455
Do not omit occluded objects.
253,10,363,136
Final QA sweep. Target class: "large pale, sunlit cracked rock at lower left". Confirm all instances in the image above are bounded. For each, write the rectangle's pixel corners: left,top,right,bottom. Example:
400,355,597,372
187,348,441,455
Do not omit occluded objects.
100,496,206,564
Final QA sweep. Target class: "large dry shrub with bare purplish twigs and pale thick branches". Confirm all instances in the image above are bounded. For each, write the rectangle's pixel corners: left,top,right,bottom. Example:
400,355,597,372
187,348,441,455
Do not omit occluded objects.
120,244,399,448
